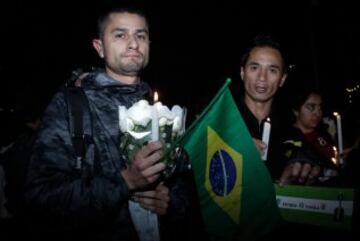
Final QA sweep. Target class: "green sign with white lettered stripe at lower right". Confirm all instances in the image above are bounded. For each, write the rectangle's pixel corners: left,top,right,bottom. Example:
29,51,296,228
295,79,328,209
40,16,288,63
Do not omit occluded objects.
275,184,354,230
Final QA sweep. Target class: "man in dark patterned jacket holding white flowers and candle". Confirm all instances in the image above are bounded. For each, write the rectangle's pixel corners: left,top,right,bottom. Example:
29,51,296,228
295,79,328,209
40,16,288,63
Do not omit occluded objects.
25,5,201,240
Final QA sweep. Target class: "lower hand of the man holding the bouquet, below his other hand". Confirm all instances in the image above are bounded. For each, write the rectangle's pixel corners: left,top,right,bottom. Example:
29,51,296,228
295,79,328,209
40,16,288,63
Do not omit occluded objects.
134,184,170,215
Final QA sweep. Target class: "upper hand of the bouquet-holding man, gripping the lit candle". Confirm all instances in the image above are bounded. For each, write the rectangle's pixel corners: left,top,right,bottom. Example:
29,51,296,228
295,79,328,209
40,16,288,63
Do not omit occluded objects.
121,141,165,190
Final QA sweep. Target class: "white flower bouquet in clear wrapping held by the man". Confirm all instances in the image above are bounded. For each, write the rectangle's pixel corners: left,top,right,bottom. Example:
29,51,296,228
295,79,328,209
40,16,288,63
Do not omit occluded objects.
119,100,186,177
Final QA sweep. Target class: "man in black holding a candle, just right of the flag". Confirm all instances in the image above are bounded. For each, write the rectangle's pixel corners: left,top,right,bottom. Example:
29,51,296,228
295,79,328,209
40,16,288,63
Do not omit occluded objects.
237,34,319,184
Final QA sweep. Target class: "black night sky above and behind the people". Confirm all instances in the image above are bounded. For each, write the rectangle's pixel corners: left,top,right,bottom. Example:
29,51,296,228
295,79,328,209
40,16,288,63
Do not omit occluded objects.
0,0,360,143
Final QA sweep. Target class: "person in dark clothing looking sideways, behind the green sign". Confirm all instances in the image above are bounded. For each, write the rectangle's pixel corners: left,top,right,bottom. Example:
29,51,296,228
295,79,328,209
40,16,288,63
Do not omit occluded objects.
282,88,339,184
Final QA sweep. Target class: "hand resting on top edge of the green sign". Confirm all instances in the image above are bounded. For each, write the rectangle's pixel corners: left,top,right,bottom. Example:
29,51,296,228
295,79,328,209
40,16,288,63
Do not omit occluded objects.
280,162,321,185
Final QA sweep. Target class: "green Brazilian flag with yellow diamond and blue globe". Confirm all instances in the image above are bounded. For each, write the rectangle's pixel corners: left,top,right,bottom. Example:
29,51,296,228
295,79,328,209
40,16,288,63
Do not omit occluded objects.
180,79,280,240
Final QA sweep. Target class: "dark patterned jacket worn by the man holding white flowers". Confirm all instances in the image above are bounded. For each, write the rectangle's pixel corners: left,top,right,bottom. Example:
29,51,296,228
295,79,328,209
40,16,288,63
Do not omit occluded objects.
25,68,197,240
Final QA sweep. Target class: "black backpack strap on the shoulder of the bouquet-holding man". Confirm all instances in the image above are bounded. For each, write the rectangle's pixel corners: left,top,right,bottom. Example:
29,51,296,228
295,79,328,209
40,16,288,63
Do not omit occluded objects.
64,70,93,169
